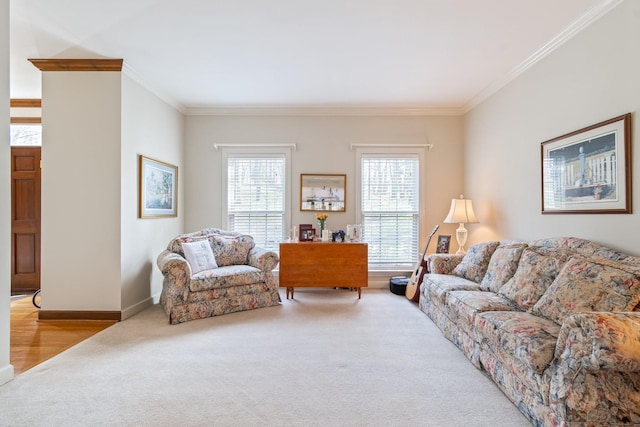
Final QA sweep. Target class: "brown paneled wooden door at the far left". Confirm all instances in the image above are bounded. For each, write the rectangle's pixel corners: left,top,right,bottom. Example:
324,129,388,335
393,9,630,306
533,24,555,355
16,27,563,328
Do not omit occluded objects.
11,147,41,293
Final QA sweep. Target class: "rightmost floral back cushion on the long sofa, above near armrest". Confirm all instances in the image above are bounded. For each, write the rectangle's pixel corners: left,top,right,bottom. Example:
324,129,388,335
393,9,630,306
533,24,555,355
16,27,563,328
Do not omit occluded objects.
533,256,640,324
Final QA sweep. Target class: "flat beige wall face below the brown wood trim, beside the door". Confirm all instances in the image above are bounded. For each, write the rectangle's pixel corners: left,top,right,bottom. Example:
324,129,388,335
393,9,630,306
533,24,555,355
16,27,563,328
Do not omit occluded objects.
41,71,122,311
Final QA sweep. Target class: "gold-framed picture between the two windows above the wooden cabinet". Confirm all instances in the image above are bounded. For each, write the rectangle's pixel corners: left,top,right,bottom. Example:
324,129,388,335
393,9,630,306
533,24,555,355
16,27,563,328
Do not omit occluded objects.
300,174,347,212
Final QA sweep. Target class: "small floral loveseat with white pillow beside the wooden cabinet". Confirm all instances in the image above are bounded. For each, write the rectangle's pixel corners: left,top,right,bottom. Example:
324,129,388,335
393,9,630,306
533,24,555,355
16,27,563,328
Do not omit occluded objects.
157,228,280,324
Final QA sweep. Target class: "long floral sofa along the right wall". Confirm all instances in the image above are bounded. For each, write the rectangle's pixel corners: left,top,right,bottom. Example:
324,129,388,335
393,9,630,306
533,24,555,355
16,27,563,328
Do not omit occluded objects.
419,237,640,426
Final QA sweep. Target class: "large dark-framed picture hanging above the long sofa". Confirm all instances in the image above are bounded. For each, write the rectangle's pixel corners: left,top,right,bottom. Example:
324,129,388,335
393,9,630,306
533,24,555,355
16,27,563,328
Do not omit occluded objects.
541,114,631,214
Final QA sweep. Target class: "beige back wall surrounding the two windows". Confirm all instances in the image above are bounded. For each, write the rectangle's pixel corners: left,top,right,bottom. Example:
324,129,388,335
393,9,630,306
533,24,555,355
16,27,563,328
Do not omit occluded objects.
184,115,463,254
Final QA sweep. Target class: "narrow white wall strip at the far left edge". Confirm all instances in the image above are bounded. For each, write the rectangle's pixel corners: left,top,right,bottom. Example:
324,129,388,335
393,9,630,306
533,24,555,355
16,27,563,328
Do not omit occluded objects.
0,0,13,384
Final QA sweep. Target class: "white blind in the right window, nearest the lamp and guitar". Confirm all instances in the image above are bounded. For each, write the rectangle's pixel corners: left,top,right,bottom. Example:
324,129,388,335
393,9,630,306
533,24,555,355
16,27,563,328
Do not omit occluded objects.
360,154,420,269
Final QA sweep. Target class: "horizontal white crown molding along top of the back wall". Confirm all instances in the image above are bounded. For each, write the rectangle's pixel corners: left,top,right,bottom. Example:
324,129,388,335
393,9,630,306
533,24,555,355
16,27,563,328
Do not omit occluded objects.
185,106,464,117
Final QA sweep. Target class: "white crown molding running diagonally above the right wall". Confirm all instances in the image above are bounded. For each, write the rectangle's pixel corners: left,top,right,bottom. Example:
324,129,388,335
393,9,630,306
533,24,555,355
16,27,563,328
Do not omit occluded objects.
463,0,625,114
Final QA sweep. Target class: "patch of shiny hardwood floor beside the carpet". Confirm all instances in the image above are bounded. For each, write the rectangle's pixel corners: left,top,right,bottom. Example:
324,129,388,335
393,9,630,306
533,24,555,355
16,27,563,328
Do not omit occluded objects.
9,295,116,375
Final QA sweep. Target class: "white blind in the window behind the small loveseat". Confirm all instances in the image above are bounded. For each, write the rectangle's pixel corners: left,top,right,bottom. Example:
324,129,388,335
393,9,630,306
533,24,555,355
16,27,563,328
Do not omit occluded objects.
227,155,286,251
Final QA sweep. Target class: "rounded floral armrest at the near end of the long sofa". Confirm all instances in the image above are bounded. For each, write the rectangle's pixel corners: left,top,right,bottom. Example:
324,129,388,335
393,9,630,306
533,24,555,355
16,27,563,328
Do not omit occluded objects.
555,312,640,372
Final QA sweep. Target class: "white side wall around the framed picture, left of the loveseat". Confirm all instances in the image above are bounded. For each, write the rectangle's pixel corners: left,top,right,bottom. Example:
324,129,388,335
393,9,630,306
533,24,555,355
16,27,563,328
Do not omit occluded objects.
121,74,185,318
